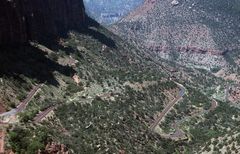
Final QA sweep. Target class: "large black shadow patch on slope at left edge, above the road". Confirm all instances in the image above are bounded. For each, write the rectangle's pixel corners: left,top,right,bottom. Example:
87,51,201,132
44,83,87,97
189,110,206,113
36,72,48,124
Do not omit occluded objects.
0,45,75,86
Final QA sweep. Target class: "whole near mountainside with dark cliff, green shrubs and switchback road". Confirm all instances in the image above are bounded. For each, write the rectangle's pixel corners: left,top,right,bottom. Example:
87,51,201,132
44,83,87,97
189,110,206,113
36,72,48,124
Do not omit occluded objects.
0,0,239,154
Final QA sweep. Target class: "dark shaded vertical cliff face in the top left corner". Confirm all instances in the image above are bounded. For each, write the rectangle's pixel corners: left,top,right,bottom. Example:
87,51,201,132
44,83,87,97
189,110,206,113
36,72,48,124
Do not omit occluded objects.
0,0,85,45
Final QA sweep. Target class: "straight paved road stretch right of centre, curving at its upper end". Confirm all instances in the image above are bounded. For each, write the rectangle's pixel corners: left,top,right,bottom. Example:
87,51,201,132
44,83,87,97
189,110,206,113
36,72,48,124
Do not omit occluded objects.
150,83,186,131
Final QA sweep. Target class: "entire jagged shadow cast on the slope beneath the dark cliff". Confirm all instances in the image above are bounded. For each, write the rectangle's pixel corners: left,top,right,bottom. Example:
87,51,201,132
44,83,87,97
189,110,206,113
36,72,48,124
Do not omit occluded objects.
0,18,113,86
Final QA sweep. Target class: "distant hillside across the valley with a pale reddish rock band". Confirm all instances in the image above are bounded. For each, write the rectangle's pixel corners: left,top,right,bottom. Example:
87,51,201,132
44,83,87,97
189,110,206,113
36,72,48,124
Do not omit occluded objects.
112,0,240,71
